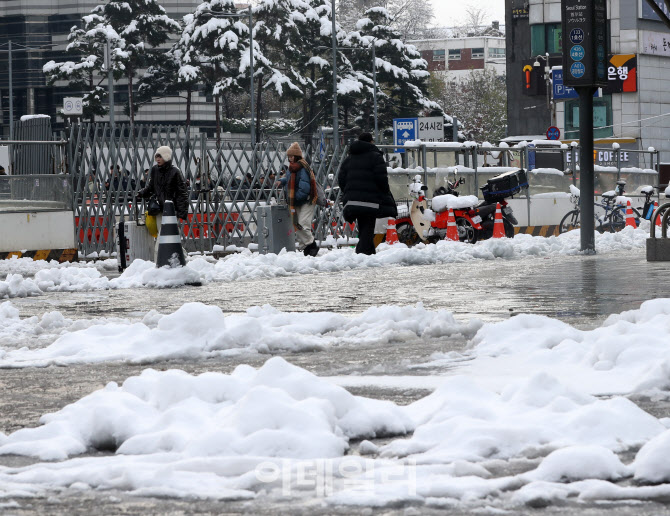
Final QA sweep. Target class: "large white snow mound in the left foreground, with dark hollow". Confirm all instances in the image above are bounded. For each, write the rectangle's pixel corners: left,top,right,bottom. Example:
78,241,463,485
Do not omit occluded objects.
0,357,412,460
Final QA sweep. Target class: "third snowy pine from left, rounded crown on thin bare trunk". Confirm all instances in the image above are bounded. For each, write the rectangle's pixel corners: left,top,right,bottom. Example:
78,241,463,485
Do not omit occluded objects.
185,0,249,143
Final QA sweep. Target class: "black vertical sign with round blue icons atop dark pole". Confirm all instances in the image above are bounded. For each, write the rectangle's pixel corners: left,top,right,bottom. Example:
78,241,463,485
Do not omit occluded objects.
561,0,609,87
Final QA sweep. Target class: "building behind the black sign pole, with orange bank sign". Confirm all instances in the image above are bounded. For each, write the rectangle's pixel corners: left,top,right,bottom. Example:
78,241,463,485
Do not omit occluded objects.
505,0,670,162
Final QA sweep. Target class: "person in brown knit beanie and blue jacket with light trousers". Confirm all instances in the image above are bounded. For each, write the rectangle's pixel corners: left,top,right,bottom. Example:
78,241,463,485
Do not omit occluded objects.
277,142,319,256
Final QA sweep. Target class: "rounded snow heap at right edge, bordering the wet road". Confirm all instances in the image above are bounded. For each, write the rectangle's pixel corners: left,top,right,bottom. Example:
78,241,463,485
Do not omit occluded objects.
452,299,670,394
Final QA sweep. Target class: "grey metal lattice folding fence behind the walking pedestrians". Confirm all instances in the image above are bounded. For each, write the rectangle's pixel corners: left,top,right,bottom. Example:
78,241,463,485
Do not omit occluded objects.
68,124,352,255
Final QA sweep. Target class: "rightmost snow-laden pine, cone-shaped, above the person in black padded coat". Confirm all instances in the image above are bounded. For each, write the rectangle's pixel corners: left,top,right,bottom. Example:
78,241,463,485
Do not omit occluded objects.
348,7,443,129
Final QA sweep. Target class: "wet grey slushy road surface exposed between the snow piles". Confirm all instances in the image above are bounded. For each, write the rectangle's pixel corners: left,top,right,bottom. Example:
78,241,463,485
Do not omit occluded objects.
0,250,670,516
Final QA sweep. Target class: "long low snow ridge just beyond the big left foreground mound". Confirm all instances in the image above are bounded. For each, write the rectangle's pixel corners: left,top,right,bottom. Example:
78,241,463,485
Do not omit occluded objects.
0,303,481,368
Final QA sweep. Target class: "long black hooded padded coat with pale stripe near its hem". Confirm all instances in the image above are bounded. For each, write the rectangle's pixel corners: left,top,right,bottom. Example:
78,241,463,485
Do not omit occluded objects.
338,140,398,220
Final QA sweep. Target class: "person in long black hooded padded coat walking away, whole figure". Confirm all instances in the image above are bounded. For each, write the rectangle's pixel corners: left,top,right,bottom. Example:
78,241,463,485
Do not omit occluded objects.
338,133,398,254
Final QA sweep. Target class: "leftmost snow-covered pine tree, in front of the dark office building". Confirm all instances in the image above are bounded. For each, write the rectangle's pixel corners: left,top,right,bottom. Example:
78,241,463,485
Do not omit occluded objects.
42,14,125,122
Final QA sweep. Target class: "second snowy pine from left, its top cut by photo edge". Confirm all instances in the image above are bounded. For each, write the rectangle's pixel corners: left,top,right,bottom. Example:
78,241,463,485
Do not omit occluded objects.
92,0,180,123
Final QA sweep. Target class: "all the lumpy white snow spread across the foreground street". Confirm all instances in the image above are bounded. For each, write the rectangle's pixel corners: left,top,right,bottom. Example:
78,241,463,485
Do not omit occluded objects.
0,298,670,510
